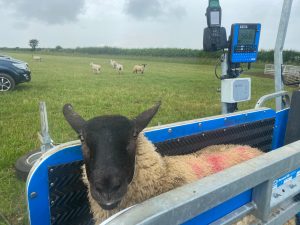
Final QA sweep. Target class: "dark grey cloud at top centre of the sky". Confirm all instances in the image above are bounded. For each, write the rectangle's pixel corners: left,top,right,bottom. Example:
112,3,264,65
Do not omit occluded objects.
124,0,186,20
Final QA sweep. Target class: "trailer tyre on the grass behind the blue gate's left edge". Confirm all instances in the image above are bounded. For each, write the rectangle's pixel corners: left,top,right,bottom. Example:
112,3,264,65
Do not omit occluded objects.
15,149,43,181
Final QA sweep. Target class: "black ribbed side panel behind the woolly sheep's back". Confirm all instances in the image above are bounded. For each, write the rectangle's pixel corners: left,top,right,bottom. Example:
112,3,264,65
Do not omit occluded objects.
155,118,275,155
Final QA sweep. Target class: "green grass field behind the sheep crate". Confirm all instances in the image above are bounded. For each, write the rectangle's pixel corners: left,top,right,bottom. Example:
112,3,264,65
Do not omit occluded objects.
0,53,282,225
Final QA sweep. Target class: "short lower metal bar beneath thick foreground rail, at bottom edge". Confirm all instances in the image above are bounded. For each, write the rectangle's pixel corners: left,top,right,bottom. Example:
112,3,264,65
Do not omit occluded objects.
210,202,256,225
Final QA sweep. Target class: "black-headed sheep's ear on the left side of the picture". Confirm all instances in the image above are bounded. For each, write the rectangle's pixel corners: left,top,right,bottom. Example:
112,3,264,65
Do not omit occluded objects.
63,104,85,134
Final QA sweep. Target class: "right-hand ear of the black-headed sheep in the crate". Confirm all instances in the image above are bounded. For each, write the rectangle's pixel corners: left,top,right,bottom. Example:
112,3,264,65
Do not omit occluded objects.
133,101,161,135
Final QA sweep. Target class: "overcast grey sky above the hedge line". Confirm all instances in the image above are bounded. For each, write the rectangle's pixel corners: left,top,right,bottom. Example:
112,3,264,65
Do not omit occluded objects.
0,0,300,50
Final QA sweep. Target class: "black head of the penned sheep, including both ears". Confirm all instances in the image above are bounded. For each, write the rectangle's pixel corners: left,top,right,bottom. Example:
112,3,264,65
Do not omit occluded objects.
63,102,160,210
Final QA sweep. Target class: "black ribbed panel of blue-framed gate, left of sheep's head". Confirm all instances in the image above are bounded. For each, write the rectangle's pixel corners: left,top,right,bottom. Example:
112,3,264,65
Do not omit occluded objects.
48,161,94,225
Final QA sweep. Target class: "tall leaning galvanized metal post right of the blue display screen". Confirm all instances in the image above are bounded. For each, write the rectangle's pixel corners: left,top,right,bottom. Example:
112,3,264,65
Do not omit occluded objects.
274,0,293,111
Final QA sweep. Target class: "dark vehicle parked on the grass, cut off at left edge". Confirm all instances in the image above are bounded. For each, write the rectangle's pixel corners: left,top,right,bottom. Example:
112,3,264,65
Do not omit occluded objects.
0,55,31,92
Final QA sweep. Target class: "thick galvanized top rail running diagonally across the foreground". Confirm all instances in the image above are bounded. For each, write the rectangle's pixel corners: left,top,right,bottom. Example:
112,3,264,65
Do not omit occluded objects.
102,141,300,225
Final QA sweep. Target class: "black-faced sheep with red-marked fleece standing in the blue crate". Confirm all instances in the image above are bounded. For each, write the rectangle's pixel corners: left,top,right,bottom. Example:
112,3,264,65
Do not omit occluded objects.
63,103,296,224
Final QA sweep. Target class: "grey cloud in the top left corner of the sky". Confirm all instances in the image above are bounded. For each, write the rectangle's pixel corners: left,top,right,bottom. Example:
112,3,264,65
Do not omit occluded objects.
0,0,85,24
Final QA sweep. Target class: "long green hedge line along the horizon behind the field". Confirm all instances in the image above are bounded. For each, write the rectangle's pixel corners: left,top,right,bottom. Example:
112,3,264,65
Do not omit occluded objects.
2,45,300,64
